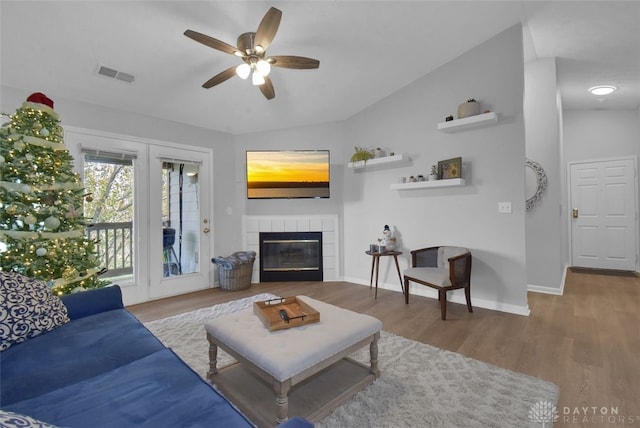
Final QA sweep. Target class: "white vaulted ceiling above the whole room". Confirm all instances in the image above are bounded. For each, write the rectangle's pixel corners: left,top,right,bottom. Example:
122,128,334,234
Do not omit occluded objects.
0,0,640,134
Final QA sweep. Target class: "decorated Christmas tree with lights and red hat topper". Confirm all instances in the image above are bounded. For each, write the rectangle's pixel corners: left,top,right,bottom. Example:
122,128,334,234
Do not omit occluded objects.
0,93,107,295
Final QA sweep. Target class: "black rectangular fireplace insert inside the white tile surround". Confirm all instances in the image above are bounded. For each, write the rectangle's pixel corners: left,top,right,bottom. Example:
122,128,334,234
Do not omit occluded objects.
260,232,323,282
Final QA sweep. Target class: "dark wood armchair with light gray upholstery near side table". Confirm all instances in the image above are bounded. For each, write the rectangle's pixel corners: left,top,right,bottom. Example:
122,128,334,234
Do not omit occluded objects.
404,246,473,320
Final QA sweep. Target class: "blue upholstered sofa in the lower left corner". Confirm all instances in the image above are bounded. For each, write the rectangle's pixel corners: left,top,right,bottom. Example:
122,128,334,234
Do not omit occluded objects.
0,286,313,428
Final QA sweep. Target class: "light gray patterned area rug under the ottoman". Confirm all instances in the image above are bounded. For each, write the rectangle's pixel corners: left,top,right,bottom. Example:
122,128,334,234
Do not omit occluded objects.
145,293,558,428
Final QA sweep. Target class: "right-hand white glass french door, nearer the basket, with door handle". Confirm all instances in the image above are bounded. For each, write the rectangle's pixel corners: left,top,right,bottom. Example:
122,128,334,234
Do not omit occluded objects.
149,146,212,298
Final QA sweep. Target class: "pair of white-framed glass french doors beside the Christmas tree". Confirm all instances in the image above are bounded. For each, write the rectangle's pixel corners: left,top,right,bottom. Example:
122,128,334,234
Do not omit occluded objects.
65,129,213,305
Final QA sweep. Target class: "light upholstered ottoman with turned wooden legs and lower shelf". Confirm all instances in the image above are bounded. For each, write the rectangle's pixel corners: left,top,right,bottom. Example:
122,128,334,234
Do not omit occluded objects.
205,296,382,426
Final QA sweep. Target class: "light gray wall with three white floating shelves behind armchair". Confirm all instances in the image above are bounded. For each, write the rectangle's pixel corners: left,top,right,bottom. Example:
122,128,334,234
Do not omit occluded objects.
343,26,528,313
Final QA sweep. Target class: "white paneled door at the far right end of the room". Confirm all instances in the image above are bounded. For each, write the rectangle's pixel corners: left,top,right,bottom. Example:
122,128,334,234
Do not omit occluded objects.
569,158,638,271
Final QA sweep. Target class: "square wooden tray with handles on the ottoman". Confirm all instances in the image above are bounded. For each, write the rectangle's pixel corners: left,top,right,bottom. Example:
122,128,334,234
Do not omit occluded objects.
253,297,320,331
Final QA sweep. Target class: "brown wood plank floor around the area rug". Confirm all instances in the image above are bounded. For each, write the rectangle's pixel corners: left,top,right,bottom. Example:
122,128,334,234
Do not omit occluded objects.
128,269,640,427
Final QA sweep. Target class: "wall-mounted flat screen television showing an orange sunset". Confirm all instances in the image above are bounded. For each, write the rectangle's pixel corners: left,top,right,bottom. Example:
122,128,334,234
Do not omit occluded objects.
247,150,330,199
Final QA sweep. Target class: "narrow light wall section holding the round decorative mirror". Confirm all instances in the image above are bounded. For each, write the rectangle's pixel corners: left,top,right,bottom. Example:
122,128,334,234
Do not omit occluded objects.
524,58,565,294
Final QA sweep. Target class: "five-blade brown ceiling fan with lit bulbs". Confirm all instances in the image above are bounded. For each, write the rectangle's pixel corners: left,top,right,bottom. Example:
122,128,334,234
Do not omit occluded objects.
184,7,320,100
